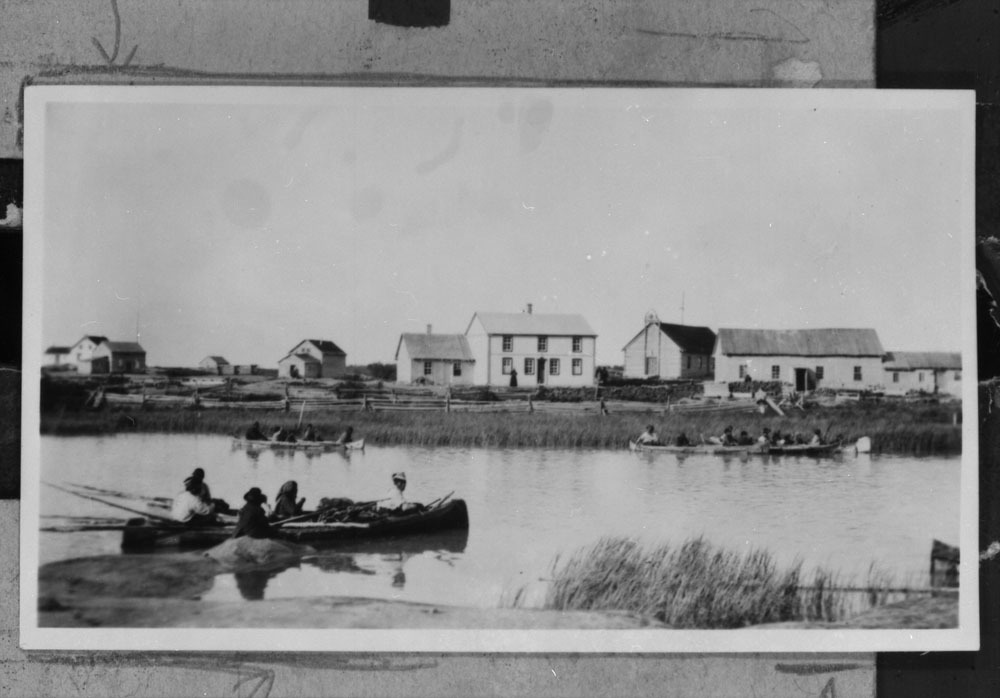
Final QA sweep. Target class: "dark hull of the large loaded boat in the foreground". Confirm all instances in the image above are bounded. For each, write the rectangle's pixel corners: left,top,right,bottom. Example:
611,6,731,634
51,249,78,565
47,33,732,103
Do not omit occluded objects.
122,499,469,551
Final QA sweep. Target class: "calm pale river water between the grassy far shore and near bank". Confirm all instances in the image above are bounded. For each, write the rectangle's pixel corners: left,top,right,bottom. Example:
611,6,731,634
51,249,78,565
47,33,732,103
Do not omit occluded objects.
39,434,960,607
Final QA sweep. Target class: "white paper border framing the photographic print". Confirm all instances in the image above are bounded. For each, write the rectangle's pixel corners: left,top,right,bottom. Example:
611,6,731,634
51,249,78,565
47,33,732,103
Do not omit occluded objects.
20,86,979,654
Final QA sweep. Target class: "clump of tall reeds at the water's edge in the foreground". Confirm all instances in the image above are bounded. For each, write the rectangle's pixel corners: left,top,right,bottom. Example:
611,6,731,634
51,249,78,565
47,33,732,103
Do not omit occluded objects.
511,537,905,629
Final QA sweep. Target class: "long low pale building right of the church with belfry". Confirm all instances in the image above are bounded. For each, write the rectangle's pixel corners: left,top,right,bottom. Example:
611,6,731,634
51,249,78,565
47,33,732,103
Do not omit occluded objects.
713,328,885,391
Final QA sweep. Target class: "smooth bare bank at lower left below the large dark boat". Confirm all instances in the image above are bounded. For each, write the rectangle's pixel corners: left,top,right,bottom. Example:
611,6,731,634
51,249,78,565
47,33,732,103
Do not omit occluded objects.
38,538,662,630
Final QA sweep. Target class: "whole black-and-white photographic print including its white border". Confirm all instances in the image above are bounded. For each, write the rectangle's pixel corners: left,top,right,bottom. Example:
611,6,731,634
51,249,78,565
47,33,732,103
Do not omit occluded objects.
20,86,979,653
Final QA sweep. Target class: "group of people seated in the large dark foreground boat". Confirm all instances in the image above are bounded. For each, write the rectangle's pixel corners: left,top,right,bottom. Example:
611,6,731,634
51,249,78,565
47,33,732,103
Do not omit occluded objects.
170,468,423,538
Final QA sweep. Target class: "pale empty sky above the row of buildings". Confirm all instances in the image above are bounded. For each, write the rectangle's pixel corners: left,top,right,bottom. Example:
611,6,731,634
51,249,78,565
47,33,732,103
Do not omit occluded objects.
35,88,973,367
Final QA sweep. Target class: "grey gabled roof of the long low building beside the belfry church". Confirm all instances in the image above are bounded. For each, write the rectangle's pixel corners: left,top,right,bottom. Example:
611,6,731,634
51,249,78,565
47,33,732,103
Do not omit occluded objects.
718,328,885,357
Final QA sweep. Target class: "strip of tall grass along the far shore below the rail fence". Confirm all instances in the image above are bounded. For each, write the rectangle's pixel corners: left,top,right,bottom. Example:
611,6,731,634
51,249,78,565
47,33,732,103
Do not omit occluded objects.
41,404,962,455
